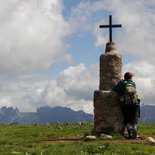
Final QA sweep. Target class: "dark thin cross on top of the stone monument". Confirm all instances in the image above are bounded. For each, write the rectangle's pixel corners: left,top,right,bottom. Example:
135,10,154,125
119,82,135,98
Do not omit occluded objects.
100,15,122,42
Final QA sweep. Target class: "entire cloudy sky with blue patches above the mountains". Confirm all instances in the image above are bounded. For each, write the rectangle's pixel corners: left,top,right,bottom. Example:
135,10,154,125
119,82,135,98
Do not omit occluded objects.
0,0,155,113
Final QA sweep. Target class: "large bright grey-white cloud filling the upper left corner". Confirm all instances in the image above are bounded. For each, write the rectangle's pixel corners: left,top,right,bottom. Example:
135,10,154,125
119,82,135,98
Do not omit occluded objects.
0,0,71,72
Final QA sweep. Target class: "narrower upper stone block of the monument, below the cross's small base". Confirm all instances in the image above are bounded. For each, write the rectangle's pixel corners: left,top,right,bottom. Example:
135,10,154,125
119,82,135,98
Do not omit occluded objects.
99,51,122,90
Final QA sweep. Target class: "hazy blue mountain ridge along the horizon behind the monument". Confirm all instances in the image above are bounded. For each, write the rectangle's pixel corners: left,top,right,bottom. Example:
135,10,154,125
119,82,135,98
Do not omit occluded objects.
0,105,155,124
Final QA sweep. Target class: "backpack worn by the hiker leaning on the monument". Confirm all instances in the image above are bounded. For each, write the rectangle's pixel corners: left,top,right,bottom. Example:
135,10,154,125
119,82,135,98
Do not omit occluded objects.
123,81,138,105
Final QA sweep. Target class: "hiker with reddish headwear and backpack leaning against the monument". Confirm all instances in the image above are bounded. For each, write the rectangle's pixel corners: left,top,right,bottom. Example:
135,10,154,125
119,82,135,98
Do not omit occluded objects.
112,72,140,139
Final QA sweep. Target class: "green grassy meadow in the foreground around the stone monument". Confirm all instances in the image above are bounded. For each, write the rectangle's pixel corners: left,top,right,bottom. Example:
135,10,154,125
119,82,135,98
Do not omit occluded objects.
0,123,155,155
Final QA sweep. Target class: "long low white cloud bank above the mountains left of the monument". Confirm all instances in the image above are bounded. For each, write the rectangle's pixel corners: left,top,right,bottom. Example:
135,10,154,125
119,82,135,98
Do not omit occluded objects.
0,64,98,113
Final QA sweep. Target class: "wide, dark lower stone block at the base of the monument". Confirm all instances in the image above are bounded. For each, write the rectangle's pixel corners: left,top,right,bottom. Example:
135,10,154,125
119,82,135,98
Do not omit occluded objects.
94,90,123,133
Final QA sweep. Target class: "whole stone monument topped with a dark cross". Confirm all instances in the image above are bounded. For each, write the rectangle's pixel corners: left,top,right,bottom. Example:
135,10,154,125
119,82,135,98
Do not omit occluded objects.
94,15,123,134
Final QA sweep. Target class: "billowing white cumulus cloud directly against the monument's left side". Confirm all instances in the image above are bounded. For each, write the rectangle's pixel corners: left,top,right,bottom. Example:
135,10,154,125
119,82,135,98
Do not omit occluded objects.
40,64,98,113
